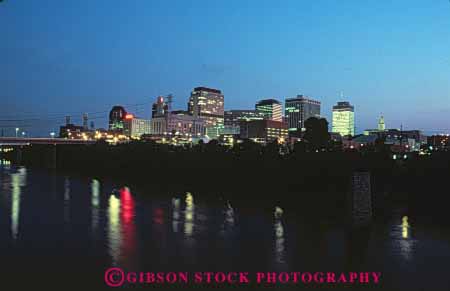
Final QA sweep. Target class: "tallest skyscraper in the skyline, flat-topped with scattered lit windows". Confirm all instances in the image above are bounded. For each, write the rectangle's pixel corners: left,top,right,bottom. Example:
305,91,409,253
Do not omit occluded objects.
188,87,224,138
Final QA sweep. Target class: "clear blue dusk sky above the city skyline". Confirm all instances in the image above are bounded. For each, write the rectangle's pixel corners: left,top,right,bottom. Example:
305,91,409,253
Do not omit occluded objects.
0,0,450,135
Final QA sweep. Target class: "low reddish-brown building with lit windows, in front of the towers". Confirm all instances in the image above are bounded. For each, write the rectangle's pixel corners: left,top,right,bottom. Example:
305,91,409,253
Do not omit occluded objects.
240,119,288,143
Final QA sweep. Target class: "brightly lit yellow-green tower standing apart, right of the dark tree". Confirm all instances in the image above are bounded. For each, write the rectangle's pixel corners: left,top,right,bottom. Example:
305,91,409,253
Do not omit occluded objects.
331,102,355,136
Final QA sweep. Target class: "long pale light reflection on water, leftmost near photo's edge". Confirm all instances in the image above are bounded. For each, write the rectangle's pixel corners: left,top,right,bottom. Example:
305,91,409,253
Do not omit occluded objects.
11,168,27,240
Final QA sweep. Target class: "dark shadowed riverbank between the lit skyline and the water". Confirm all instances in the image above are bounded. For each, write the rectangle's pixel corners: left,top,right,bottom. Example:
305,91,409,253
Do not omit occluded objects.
3,143,450,225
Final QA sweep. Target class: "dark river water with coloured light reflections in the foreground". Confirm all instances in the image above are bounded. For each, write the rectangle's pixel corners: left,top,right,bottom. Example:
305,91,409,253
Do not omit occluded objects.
0,161,450,290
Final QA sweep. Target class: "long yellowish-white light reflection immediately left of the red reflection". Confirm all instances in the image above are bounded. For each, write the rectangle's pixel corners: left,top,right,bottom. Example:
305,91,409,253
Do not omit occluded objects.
108,194,122,265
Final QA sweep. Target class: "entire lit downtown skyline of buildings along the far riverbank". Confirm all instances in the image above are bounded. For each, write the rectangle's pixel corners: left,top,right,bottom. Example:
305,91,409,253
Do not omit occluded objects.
60,87,442,151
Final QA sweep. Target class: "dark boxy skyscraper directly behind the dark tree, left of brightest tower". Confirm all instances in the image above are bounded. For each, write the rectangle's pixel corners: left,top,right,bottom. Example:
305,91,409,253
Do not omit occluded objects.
285,95,320,131
